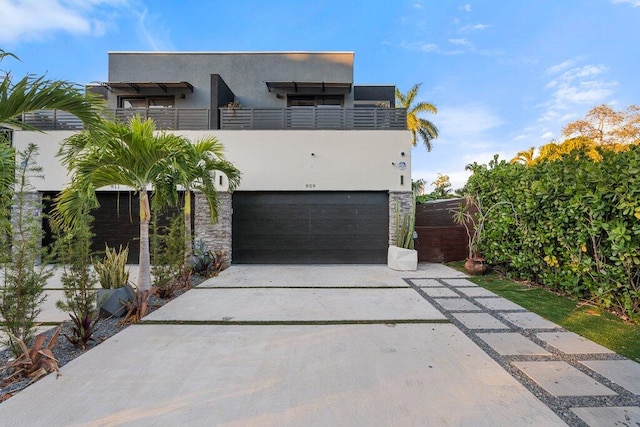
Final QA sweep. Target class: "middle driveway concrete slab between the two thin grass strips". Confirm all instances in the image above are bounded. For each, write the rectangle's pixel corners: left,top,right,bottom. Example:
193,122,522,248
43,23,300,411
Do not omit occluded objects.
145,288,445,321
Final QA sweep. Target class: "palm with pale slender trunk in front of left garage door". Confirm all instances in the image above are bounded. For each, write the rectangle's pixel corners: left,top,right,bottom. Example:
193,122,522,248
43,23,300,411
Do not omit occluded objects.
53,117,238,291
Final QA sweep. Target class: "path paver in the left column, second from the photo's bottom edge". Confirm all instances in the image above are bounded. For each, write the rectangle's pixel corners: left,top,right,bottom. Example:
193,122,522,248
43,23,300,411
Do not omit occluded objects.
513,361,616,396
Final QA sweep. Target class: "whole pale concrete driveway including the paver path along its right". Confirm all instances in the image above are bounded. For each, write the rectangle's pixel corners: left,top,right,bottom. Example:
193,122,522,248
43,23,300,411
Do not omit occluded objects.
0,264,640,426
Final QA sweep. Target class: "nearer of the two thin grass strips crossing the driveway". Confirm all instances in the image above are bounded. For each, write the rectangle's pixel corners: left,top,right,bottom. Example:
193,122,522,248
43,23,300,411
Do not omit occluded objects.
134,319,451,326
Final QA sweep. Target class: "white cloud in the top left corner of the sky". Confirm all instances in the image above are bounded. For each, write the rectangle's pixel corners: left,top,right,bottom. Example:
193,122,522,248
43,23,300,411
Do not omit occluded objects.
0,0,128,43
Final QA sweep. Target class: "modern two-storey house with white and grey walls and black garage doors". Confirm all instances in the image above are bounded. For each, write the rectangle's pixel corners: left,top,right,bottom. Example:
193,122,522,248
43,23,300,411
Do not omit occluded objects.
12,52,411,263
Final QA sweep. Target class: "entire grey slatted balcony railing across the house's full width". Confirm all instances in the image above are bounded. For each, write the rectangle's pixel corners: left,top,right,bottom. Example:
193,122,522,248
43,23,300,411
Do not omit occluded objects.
22,107,407,130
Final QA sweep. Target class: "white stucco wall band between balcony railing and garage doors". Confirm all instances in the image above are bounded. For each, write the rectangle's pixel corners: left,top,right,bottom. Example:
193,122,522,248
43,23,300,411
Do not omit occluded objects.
14,130,411,191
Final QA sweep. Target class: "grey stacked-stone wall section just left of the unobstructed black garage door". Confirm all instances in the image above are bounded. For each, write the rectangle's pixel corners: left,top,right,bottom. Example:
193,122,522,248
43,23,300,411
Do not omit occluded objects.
193,192,232,262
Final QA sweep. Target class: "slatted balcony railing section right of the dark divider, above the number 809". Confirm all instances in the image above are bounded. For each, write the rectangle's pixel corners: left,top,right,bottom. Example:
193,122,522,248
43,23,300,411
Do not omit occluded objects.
220,107,407,130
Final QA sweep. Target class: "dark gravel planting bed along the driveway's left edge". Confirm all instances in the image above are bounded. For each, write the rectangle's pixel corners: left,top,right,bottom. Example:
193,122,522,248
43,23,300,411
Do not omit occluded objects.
0,276,205,405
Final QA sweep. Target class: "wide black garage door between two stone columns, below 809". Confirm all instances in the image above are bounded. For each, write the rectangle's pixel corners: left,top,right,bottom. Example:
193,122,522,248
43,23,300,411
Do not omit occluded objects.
232,192,389,264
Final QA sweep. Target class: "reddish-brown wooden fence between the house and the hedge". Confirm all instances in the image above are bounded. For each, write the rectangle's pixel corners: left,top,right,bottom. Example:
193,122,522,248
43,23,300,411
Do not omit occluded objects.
416,199,468,262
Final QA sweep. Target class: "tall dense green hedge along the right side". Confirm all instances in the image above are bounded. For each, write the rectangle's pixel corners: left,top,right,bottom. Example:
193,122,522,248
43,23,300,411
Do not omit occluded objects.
465,145,640,319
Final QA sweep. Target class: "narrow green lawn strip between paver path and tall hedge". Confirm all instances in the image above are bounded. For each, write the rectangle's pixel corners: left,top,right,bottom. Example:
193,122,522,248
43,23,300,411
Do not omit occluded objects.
449,263,640,362
